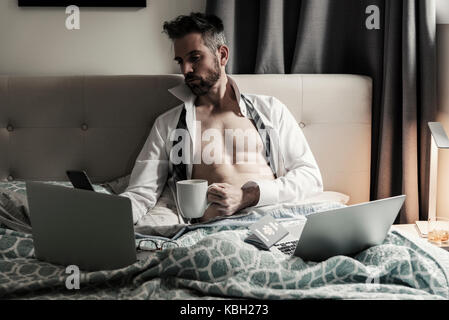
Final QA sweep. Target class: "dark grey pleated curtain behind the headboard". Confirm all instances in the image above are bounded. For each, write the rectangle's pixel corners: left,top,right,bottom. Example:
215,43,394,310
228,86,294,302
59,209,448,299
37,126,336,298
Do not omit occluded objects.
206,0,437,223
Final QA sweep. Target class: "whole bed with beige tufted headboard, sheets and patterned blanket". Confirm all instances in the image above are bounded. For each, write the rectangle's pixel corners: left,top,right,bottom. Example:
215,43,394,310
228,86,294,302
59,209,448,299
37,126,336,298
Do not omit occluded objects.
0,75,449,299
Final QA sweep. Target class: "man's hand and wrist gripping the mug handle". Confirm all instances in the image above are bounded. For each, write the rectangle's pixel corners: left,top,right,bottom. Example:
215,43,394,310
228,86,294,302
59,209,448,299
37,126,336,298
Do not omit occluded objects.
203,183,259,216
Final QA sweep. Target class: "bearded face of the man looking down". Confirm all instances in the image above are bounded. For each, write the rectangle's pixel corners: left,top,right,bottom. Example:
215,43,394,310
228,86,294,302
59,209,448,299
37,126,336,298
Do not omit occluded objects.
174,33,222,96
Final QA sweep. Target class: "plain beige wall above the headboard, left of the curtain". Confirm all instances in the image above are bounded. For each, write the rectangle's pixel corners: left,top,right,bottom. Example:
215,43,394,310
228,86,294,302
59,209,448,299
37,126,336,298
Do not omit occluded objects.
0,0,206,75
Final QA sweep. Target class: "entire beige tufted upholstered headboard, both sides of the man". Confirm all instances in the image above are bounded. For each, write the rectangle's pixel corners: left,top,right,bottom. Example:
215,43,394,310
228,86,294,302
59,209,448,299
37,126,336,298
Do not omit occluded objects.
0,75,372,203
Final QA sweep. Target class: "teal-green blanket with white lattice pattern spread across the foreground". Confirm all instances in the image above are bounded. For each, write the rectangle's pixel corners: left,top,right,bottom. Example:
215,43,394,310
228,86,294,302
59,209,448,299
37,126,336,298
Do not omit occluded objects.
0,218,449,299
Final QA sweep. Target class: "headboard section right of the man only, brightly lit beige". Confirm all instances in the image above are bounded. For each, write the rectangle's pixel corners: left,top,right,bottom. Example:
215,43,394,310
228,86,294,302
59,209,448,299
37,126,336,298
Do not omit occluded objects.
233,74,372,204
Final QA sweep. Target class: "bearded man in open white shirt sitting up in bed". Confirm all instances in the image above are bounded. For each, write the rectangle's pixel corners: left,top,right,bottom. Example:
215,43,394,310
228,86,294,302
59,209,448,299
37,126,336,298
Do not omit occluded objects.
122,13,323,223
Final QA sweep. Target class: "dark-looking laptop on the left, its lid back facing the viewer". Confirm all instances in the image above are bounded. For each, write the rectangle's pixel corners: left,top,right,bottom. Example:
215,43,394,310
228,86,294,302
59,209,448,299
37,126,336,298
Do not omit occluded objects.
26,182,142,271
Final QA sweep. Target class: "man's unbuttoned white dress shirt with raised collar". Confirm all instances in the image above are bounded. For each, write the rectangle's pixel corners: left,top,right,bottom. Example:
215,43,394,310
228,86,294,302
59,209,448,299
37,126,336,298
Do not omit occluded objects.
120,76,323,223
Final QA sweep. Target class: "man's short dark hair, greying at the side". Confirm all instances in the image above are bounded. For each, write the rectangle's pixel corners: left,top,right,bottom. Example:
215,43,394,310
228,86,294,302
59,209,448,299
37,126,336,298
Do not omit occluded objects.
163,12,226,53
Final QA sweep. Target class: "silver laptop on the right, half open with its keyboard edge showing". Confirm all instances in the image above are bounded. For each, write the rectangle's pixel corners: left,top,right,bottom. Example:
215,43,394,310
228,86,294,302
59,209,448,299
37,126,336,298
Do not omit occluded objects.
270,195,405,261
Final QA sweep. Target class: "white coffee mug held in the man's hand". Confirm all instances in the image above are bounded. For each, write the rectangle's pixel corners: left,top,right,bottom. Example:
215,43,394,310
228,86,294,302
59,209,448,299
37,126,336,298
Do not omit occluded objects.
176,179,210,219
